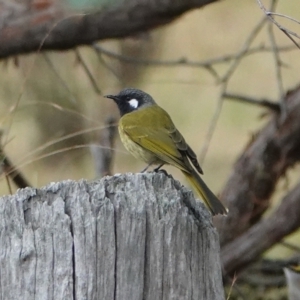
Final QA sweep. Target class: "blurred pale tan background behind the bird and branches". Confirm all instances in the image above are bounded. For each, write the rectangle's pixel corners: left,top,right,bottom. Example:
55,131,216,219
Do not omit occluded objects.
0,0,300,299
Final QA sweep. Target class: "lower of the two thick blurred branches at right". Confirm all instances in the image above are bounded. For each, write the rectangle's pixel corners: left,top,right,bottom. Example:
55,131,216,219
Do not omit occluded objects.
221,180,300,275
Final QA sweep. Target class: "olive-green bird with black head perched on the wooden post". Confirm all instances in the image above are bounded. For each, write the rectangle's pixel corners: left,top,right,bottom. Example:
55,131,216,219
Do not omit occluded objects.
105,88,228,215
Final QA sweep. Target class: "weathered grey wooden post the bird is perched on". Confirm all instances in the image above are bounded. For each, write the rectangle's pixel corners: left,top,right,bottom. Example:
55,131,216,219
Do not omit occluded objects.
0,173,224,300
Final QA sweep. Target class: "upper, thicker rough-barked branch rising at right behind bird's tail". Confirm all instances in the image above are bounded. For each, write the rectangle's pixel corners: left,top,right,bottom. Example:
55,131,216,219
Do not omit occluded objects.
215,87,300,247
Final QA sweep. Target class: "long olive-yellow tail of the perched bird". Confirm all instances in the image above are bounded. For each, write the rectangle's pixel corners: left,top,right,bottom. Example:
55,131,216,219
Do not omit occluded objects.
182,171,228,215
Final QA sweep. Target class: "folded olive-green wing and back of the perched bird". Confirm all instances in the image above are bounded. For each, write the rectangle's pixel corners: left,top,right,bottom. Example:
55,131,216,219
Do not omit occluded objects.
120,106,201,173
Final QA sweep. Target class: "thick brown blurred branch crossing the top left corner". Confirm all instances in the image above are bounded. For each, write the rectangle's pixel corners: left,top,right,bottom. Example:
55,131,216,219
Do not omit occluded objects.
0,0,217,58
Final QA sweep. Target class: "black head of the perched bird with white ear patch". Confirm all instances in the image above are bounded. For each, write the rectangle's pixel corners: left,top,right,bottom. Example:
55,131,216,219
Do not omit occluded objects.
105,88,156,116
